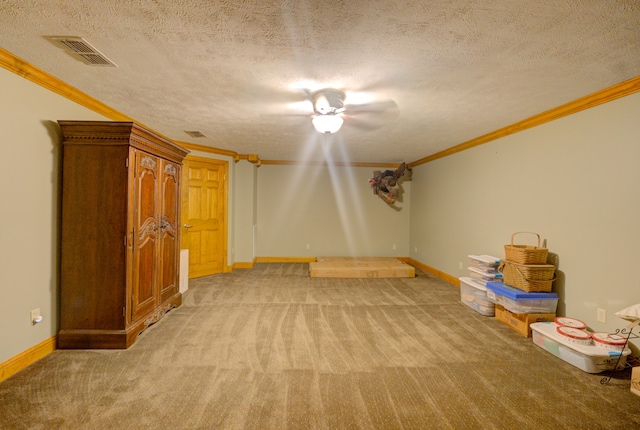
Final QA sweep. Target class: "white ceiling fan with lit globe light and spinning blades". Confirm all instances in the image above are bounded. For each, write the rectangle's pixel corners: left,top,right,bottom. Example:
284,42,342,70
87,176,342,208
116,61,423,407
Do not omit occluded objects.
266,88,398,134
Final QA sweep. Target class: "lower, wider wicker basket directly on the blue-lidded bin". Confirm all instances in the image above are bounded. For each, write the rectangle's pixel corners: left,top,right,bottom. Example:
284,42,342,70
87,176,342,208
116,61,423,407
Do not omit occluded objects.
498,260,556,293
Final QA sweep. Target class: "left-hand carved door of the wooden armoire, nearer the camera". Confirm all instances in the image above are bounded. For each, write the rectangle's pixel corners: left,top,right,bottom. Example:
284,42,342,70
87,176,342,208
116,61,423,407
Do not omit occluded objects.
131,151,160,320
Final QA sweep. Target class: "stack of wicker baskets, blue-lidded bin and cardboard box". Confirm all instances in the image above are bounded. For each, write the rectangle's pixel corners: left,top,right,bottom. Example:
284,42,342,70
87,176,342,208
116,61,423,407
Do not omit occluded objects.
487,232,558,337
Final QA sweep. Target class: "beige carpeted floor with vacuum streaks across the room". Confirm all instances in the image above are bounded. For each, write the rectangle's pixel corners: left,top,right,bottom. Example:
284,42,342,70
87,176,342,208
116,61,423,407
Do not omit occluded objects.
0,263,640,430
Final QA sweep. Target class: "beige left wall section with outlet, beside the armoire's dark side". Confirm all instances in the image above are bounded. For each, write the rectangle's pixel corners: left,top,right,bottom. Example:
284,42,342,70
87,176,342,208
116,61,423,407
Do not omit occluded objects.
0,68,106,363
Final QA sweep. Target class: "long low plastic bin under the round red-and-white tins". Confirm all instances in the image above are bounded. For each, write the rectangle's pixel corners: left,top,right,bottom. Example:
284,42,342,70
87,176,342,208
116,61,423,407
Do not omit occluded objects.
531,322,631,373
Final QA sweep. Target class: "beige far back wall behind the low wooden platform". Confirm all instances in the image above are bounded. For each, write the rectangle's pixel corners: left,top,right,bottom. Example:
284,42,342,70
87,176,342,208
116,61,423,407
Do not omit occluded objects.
257,165,411,257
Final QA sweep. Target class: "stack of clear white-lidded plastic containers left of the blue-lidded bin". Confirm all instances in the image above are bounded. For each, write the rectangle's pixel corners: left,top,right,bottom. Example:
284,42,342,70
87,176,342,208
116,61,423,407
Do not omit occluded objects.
459,255,502,317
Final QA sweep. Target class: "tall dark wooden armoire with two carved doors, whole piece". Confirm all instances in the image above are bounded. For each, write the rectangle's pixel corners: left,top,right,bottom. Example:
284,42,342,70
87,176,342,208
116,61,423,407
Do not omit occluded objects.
58,121,188,349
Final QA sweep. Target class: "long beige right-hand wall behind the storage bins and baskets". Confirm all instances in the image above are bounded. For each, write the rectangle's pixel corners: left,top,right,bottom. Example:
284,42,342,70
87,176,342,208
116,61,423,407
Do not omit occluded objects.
410,93,640,346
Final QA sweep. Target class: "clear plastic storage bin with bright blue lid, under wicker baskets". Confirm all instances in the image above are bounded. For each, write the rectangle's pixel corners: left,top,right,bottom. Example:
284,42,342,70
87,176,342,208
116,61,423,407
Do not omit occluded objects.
486,282,558,314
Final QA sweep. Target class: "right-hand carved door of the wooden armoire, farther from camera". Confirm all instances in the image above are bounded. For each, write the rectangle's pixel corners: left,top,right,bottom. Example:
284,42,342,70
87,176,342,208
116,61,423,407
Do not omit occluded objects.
158,160,180,303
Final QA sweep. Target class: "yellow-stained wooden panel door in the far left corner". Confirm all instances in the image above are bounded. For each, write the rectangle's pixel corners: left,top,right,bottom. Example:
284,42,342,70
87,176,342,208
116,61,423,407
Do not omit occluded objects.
182,157,228,278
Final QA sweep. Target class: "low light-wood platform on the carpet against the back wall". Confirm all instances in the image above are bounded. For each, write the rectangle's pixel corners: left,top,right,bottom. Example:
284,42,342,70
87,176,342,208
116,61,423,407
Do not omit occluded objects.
309,257,416,278
